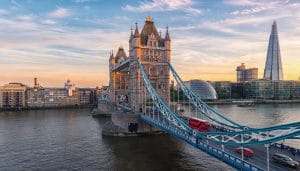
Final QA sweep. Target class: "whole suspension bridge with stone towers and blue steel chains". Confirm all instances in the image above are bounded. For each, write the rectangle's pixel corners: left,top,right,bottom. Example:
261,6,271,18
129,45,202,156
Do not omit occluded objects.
102,17,300,171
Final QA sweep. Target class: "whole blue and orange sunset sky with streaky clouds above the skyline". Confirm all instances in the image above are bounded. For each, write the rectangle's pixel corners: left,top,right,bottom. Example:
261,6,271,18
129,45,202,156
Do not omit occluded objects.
0,0,300,87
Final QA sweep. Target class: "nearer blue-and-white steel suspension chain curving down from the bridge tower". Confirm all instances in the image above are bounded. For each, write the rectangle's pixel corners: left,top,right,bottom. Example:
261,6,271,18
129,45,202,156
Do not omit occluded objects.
136,60,300,146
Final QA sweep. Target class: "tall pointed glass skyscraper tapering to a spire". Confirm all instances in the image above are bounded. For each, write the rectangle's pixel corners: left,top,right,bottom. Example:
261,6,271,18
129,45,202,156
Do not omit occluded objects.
264,21,283,80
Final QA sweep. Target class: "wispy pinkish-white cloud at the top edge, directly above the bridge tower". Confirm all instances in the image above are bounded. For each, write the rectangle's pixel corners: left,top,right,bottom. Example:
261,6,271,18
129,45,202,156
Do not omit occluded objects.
123,0,202,15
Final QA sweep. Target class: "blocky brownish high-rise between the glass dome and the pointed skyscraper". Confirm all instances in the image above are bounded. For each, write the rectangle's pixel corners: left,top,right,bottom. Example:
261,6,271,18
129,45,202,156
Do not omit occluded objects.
236,63,258,83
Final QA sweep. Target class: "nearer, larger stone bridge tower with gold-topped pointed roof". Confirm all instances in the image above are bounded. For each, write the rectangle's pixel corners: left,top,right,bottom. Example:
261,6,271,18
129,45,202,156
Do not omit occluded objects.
129,16,171,114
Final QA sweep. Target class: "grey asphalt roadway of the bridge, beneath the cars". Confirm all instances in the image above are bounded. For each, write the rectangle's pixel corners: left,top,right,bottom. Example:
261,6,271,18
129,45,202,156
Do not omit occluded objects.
203,128,300,171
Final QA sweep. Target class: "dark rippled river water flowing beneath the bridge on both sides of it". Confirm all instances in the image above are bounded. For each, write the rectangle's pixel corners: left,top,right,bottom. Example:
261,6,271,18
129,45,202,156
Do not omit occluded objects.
0,104,300,170
